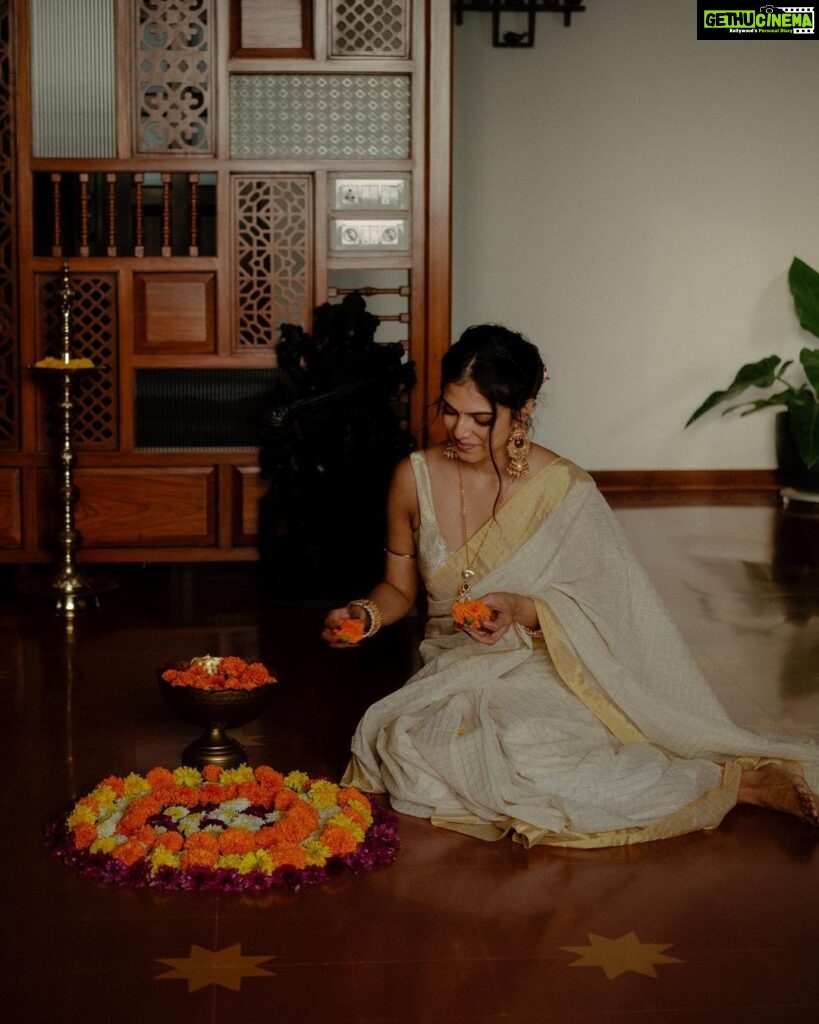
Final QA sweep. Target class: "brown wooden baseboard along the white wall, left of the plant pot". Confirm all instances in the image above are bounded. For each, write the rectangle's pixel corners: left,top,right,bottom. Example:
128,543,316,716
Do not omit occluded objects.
591,469,781,506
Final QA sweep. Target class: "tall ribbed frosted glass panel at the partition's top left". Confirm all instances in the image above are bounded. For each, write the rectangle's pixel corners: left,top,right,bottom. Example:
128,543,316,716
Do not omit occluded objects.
31,0,117,157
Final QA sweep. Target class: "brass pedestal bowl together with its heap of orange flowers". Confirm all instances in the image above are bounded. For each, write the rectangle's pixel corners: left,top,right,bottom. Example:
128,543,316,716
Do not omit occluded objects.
158,654,276,768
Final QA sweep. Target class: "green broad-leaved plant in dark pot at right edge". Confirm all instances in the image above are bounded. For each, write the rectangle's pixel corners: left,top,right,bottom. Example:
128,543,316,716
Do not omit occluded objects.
686,257,819,492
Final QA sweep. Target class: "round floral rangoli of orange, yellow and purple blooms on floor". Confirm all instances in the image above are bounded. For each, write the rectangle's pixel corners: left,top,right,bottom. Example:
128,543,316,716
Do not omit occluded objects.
46,765,398,892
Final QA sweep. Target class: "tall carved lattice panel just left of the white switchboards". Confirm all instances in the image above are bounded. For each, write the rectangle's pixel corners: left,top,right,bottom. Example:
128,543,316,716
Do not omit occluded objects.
233,174,312,351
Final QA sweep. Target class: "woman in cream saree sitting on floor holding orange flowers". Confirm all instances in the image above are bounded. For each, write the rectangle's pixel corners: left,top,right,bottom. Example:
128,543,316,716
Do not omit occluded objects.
322,325,819,847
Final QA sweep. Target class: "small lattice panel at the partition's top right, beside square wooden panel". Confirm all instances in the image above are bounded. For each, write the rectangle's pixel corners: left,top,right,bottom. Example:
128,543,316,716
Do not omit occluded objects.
329,0,410,57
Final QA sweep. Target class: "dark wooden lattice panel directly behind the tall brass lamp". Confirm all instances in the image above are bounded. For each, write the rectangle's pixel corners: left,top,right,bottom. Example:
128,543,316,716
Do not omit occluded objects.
36,273,119,452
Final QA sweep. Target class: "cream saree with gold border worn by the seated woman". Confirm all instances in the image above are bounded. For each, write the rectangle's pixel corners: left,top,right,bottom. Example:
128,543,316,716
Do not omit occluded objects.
345,453,819,847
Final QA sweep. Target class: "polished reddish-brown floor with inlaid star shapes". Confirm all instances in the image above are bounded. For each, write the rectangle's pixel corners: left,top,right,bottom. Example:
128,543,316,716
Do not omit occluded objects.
0,507,819,1024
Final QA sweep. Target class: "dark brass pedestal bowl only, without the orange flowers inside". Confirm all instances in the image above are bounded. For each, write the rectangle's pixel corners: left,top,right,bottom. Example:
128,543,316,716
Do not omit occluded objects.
157,663,275,768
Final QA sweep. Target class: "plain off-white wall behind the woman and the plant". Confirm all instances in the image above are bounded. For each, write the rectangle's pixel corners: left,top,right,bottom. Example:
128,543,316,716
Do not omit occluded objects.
452,0,819,469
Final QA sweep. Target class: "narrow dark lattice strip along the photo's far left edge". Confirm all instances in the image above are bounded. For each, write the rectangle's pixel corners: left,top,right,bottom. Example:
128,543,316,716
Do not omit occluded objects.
0,0,18,450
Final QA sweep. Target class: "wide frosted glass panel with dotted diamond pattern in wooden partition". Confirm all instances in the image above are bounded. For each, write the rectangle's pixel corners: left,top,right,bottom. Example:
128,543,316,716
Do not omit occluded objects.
230,75,410,160
